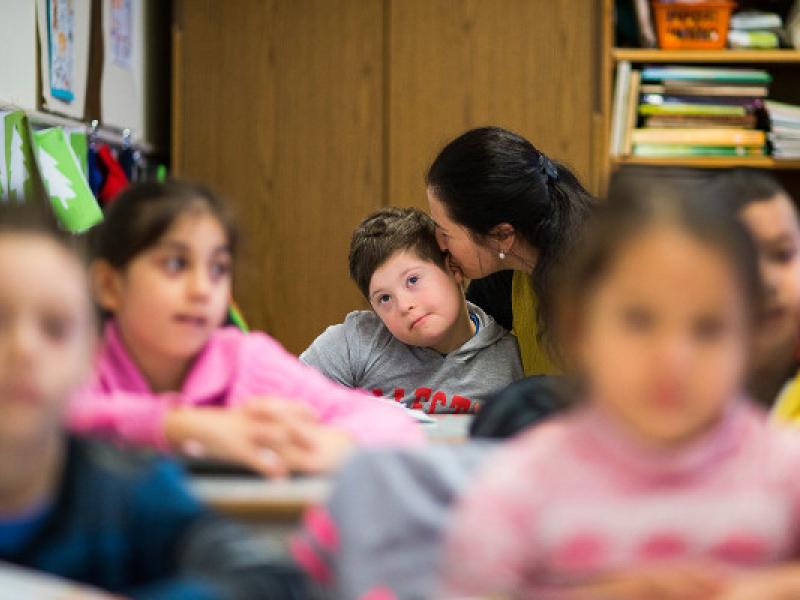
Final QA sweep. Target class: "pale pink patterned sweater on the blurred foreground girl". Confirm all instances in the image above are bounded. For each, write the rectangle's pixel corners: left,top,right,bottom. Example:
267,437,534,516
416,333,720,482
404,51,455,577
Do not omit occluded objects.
437,402,800,599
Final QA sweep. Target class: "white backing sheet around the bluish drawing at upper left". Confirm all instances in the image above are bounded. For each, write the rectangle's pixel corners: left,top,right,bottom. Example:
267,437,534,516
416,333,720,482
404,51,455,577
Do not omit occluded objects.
36,0,92,120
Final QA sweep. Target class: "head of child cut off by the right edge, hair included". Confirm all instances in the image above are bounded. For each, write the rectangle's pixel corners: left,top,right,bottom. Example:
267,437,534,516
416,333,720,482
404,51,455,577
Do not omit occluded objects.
721,169,800,382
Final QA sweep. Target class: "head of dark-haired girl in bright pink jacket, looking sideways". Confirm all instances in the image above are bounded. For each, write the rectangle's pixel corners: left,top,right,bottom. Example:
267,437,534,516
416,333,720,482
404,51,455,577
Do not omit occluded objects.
92,181,236,360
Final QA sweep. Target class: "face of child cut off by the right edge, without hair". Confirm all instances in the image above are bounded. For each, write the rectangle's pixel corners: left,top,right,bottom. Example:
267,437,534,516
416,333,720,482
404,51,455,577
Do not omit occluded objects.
740,194,800,366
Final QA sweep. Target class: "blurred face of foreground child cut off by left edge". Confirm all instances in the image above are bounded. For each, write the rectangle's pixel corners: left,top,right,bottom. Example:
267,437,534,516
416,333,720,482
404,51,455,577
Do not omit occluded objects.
0,233,94,444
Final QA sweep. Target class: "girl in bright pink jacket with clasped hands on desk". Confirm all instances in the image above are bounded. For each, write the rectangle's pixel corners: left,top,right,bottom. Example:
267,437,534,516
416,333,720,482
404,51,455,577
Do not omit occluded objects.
71,182,420,475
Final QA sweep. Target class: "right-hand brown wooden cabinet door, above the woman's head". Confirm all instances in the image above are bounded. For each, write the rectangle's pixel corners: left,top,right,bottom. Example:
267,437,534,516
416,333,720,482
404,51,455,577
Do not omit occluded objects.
388,0,602,206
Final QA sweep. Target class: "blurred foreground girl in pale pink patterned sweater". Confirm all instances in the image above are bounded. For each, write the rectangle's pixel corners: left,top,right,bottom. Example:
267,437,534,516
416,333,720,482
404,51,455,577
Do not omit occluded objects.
442,178,800,600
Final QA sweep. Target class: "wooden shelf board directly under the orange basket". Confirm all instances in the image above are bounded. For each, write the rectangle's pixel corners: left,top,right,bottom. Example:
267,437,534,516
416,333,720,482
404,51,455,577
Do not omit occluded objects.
611,48,800,64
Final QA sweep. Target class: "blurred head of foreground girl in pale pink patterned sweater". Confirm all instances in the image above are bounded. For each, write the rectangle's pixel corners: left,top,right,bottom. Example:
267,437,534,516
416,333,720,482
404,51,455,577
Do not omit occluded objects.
562,176,761,445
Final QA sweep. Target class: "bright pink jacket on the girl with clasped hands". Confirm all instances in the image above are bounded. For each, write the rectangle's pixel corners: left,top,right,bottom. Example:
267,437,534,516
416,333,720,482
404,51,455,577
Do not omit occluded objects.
69,321,422,449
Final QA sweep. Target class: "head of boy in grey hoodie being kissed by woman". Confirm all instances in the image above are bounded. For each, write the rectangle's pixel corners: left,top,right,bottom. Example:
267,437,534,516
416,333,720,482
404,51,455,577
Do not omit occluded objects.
350,208,468,352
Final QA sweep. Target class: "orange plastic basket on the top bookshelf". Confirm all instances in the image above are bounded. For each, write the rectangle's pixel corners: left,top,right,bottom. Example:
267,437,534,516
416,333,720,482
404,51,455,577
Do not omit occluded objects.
652,0,736,50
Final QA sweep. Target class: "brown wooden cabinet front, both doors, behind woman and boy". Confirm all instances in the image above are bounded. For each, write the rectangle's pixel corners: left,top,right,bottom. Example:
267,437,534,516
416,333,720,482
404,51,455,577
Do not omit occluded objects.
172,0,602,352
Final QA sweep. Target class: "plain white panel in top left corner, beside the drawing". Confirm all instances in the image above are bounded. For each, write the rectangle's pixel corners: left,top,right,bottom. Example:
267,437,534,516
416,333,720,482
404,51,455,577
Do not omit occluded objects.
0,0,38,110
